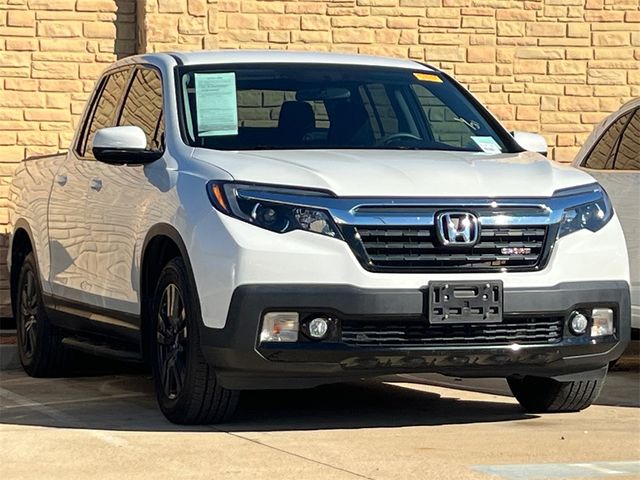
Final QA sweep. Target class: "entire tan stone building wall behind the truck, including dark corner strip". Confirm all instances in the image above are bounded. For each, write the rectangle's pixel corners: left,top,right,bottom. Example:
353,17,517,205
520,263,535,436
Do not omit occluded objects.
0,0,640,317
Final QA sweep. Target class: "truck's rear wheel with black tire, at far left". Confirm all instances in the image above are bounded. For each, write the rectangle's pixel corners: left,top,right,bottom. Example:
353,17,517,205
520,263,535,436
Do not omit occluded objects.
16,252,69,377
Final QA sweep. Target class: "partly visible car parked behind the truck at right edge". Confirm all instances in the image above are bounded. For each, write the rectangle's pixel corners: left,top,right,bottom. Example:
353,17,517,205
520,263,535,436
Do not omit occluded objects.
573,98,640,335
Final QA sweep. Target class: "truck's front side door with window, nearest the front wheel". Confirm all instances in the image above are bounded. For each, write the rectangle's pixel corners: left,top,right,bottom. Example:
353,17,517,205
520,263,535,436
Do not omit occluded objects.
81,66,166,318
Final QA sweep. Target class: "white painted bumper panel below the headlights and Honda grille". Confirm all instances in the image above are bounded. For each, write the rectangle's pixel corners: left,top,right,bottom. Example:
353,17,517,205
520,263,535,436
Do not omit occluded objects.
191,210,629,328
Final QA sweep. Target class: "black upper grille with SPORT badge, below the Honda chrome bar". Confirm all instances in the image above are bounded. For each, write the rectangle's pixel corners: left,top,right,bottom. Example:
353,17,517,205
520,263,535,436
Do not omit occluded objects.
354,226,547,272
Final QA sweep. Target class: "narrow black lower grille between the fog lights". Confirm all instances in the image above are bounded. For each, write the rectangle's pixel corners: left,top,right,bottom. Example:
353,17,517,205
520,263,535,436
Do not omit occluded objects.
342,317,563,347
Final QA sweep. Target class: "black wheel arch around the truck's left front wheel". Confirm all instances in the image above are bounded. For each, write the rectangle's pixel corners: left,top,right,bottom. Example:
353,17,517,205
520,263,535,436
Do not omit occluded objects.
140,223,200,359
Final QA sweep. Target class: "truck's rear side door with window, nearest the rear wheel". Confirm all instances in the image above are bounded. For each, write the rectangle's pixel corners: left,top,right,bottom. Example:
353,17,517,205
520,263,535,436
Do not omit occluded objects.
49,69,129,303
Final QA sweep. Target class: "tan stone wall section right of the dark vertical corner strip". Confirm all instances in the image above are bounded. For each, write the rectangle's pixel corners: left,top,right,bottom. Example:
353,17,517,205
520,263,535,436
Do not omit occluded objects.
144,0,640,161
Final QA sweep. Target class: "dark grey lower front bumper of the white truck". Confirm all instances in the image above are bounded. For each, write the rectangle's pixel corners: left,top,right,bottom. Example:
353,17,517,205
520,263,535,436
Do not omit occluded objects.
200,281,631,389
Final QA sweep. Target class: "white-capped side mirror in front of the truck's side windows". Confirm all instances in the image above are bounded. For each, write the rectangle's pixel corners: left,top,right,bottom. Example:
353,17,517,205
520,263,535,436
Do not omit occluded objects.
92,126,162,165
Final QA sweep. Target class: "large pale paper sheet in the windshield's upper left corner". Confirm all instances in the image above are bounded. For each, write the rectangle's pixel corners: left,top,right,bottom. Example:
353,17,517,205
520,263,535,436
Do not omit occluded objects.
195,72,238,137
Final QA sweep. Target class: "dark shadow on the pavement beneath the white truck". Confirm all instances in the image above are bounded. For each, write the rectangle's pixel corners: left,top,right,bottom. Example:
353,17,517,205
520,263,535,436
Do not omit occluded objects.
0,361,535,432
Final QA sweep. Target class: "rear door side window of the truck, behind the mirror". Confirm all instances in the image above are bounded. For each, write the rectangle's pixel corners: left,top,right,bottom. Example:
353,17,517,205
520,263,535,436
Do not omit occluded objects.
78,70,129,158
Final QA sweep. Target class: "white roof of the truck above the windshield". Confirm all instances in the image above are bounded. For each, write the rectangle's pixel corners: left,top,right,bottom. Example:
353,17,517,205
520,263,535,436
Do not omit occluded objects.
162,50,433,71
